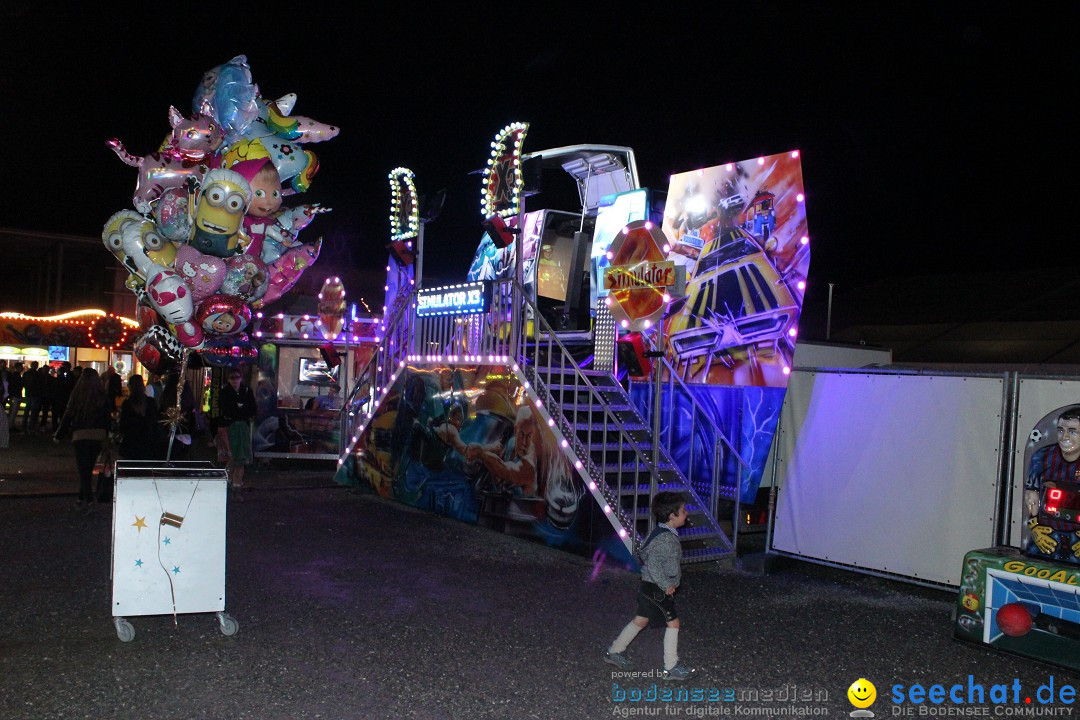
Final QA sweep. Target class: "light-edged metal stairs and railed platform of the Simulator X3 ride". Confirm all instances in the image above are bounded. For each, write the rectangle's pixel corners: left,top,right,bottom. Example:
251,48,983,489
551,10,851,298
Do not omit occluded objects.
339,282,734,563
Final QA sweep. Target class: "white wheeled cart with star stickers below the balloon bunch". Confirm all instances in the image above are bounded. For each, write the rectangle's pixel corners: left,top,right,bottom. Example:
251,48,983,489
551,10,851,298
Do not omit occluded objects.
110,460,240,642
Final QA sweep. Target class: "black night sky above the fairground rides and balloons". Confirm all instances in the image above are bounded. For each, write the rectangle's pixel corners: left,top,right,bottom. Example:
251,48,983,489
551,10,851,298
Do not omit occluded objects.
0,2,1080,334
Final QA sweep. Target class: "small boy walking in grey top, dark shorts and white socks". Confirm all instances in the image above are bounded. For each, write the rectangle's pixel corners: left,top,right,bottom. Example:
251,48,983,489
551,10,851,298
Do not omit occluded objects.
604,492,694,680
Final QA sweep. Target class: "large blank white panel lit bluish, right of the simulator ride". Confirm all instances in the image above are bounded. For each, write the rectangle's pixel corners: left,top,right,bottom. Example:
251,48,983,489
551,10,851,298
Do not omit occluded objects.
772,371,1004,585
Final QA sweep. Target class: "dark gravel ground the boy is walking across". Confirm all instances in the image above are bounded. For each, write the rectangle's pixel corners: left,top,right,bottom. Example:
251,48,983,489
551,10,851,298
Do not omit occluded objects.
0,488,1080,720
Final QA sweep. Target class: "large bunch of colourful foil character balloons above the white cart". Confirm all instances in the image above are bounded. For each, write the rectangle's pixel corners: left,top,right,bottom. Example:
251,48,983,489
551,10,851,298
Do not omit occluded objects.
102,55,338,372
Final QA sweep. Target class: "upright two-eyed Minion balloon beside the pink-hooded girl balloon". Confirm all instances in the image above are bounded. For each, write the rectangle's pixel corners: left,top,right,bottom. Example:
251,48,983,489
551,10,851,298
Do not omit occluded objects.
190,168,252,258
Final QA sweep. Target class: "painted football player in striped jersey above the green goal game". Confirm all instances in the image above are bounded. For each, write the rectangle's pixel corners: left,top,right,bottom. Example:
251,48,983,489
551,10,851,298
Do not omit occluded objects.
1024,408,1080,562
